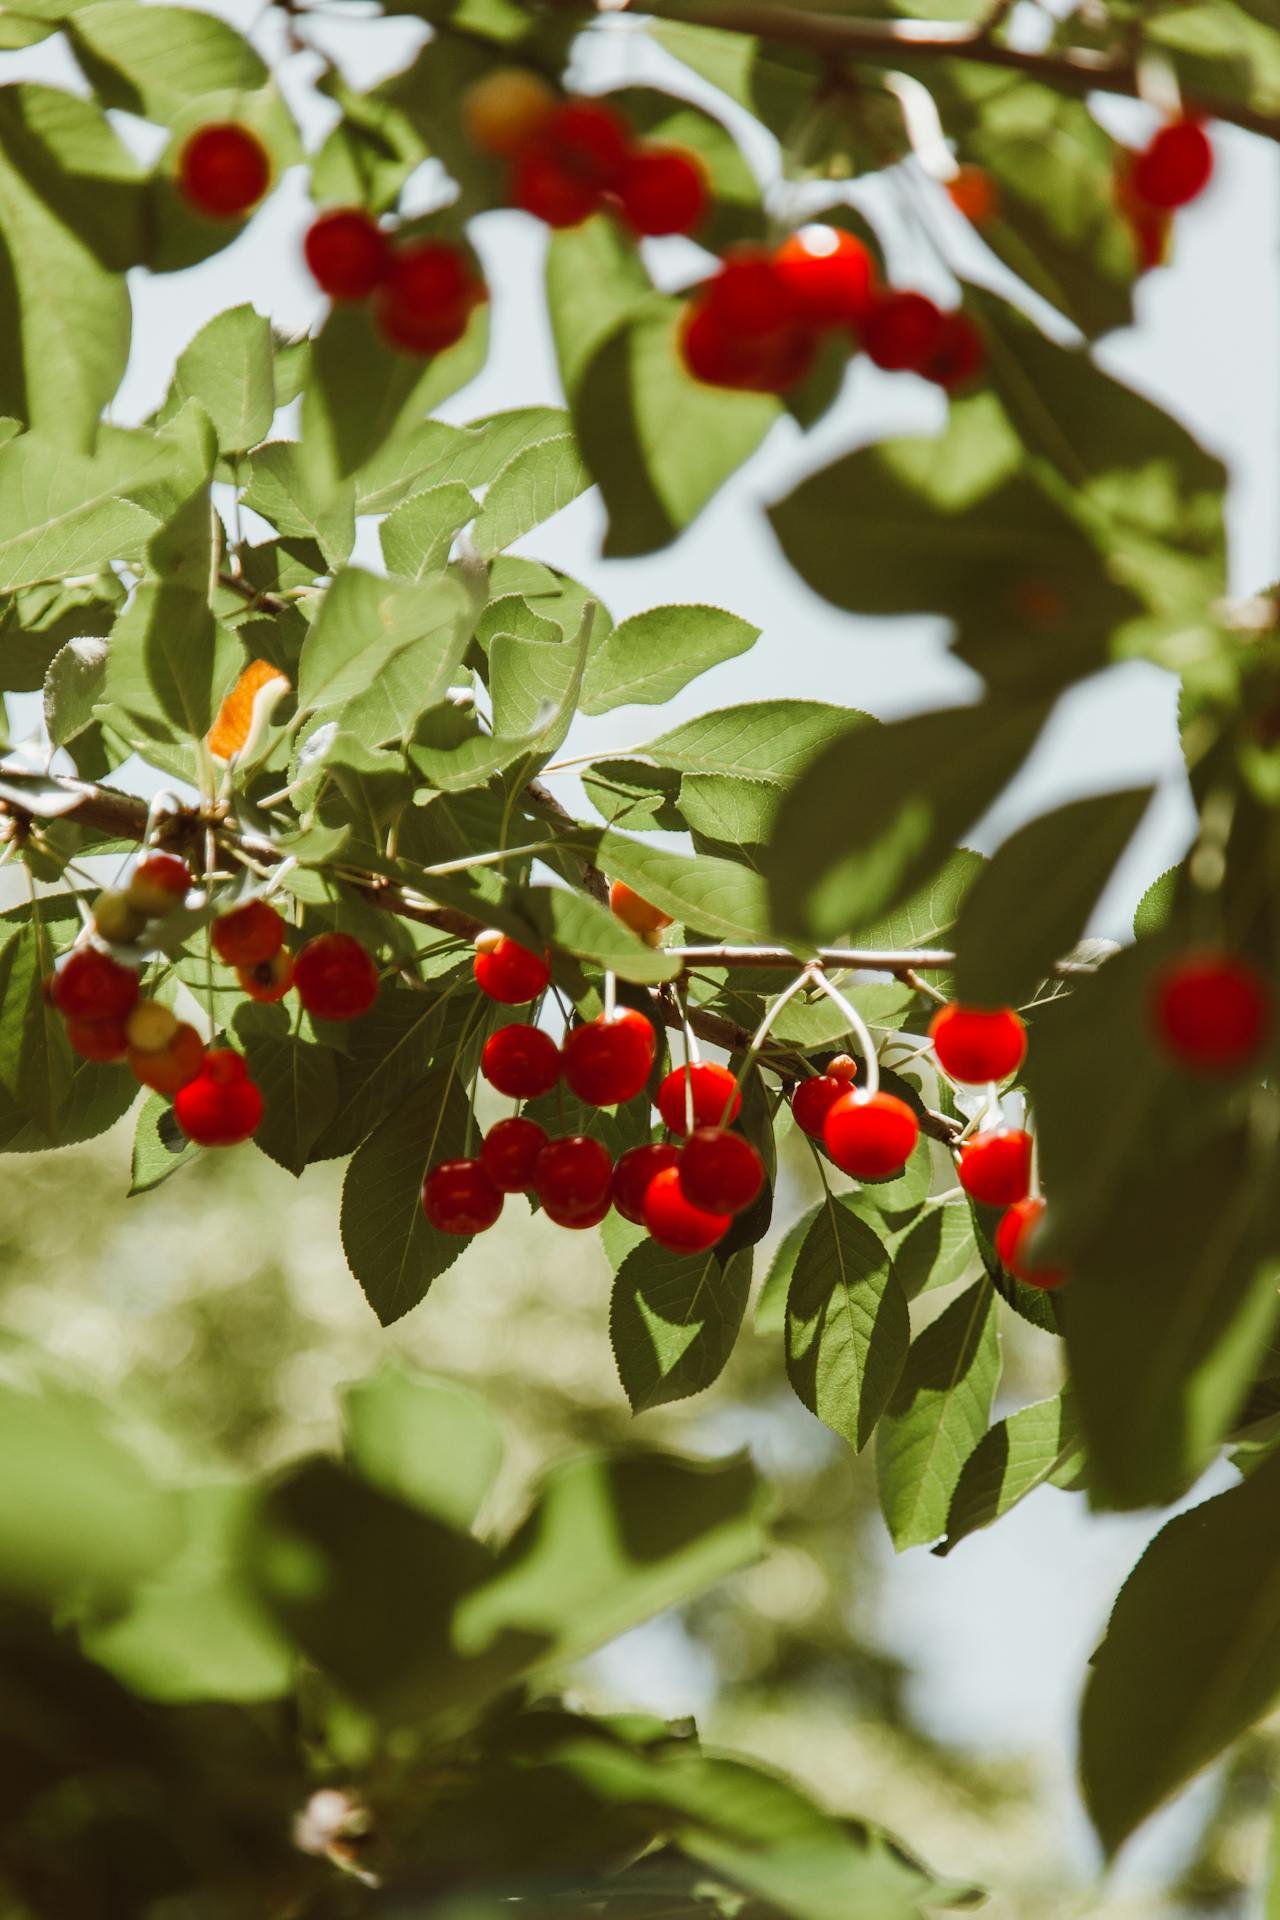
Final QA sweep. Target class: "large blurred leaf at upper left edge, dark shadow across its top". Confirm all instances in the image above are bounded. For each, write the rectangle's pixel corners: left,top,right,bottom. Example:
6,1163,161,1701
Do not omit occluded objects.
0,86,138,453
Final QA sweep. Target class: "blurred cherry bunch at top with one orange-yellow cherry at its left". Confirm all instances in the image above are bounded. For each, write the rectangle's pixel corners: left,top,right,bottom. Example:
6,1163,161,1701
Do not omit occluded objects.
462,67,710,236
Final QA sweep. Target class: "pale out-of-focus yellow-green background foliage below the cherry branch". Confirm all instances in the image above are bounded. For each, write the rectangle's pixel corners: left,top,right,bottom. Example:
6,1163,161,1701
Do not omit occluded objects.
0,1123,1280,1920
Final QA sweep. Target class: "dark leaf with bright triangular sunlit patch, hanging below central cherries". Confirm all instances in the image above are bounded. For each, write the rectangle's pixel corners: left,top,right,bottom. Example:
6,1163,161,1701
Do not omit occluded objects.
608,1240,750,1413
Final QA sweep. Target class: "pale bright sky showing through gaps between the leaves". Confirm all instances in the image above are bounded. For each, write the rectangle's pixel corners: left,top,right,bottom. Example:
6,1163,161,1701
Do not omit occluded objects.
0,6,1280,1904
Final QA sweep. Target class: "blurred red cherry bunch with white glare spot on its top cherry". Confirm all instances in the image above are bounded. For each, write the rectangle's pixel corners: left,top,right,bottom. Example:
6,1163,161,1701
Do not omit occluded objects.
679,227,986,394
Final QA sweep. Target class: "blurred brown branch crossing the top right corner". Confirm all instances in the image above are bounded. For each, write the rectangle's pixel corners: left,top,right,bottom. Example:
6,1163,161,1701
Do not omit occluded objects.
624,0,1280,140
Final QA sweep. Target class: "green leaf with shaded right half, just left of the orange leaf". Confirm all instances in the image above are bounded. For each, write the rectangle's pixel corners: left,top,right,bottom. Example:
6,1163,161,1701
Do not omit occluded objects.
106,586,244,745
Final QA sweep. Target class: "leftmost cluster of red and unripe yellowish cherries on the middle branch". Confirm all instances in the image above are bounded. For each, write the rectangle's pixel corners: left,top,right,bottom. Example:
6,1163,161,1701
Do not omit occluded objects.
44,867,378,1146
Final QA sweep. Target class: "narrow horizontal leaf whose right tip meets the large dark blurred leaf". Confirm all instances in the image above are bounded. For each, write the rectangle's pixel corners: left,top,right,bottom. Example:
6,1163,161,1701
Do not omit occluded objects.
637,701,869,785
